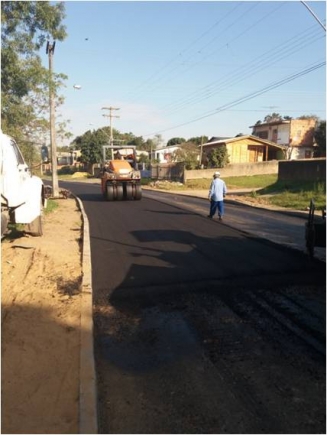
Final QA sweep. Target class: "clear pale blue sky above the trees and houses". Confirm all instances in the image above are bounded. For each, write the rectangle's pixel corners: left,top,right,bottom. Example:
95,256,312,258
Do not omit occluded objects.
42,1,326,145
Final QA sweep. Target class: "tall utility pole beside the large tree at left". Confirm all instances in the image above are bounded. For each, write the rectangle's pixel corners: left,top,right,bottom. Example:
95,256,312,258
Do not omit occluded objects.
46,41,59,198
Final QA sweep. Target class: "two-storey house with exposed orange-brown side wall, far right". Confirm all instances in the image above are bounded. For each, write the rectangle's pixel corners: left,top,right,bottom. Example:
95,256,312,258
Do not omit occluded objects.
250,118,316,159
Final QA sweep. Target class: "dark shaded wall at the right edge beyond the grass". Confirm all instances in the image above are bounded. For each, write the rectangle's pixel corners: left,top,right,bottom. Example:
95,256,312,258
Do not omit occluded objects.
278,158,326,181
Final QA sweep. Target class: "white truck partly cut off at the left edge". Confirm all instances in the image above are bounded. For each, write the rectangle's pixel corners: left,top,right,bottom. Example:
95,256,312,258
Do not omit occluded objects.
0,131,46,238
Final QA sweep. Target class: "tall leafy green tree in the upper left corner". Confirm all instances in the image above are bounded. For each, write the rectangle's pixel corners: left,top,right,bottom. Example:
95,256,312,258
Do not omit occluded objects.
1,1,66,160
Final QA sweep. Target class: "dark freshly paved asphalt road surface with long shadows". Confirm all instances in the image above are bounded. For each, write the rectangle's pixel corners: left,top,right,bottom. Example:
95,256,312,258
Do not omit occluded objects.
61,183,326,433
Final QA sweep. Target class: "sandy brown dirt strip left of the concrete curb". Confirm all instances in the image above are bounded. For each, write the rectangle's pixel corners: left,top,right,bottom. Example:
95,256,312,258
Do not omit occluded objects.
1,198,82,434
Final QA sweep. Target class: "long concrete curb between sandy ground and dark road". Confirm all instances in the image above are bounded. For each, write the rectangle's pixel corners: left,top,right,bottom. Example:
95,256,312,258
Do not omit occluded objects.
75,197,98,434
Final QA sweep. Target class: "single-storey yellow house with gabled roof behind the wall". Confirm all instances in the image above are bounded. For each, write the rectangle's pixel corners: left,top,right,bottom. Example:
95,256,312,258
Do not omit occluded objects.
201,135,286,166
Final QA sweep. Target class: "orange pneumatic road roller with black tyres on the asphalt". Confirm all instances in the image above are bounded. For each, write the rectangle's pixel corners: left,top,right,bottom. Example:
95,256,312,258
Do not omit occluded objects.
100,145,142,201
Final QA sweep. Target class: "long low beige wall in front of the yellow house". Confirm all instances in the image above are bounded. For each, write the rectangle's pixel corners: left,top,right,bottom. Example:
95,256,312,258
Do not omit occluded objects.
184,160,278,182
